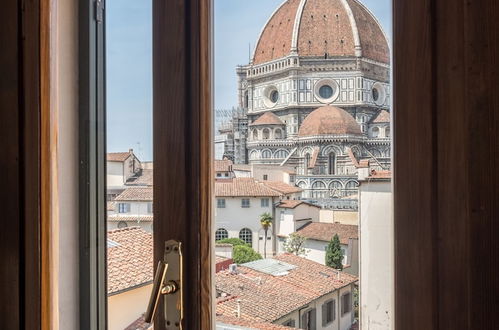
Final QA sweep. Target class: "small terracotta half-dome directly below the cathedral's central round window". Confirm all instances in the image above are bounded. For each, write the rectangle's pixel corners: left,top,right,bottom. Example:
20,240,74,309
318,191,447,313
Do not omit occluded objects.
298,105,362,137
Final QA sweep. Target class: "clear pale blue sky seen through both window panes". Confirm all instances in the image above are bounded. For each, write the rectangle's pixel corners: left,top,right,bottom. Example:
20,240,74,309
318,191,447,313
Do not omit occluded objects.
106,0,391,161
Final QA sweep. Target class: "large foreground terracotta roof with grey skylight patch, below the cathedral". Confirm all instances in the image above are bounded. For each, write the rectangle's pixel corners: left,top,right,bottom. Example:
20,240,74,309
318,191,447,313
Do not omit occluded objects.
215,254,357,322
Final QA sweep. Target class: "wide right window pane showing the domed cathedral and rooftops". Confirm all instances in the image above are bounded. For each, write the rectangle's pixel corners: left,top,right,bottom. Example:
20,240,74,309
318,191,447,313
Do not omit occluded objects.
214,0,394,329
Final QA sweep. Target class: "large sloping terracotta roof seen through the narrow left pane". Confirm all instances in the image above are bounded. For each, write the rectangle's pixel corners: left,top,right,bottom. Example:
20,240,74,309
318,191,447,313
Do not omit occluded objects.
107,227,153,295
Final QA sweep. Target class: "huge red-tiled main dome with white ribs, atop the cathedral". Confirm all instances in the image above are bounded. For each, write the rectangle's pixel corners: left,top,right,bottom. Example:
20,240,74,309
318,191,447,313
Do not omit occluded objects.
253,0,390,64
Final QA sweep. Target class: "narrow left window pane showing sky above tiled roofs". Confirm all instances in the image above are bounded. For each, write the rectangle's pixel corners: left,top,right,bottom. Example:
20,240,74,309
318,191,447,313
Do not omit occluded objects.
105,0,152,330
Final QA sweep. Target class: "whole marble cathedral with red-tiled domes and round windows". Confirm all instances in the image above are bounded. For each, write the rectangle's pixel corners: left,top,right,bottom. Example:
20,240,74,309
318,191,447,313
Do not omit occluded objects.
217,0,391,200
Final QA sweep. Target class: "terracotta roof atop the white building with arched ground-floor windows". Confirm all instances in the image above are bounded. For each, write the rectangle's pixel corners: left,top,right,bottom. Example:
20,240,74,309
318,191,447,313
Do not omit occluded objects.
215,178,281,197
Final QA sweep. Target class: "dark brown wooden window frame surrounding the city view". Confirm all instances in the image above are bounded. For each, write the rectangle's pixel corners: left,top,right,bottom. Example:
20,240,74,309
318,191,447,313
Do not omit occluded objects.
0,0,499,330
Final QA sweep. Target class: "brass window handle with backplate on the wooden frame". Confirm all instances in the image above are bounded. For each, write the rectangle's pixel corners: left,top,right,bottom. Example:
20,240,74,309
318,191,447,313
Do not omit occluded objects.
144,240,183,329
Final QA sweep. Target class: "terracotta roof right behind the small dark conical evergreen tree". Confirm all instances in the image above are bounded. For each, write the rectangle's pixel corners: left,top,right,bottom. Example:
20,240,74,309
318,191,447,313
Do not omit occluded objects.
296,222,359,244
